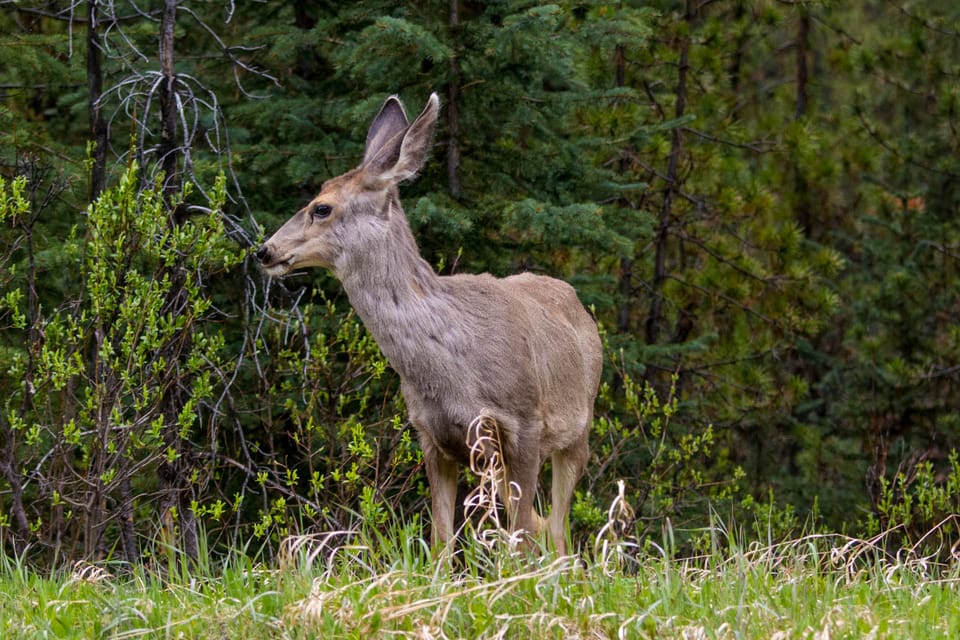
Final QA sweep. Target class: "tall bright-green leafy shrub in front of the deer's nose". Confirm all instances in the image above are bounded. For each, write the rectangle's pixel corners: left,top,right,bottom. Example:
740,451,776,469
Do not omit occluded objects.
0,168,242,560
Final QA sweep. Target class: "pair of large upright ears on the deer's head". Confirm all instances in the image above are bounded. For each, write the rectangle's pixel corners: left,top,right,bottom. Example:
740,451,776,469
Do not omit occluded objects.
364,93,440,184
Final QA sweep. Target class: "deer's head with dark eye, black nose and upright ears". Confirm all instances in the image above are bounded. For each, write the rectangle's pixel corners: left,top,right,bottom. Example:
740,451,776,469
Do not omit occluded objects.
257,93,440,276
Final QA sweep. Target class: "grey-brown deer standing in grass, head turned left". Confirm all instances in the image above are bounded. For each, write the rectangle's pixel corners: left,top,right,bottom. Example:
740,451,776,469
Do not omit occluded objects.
256,93,602,556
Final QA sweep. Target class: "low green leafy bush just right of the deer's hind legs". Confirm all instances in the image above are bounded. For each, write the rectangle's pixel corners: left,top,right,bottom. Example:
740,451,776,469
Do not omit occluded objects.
573,328,746,548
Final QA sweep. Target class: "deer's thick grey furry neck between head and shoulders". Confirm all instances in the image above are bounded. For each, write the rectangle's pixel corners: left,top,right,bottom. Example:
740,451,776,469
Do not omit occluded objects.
337,204,456,384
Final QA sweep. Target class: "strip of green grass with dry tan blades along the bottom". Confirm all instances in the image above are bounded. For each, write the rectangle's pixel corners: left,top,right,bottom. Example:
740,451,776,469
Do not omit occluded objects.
0,525,960,640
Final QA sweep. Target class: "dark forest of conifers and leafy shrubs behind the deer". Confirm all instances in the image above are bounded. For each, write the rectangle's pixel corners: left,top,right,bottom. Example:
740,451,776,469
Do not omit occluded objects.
0,0,960,561
